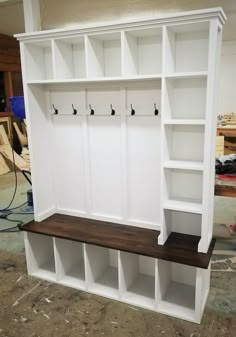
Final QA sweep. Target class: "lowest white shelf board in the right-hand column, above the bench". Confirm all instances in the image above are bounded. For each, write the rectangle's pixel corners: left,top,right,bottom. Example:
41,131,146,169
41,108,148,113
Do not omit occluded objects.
164,199,202,214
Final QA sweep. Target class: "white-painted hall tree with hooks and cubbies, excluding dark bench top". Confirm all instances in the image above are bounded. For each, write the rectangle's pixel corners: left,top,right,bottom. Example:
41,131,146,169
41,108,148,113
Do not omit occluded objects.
16,8,226,322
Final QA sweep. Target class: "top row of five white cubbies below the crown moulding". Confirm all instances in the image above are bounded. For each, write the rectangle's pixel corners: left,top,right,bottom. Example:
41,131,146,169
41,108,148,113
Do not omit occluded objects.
23,21,210,84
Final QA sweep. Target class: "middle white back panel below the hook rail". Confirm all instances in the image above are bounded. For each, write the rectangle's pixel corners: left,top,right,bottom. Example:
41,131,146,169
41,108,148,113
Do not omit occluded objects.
88,116,122,218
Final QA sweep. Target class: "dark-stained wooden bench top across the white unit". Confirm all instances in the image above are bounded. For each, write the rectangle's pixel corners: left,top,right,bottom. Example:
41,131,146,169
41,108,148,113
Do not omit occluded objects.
21,214,215,269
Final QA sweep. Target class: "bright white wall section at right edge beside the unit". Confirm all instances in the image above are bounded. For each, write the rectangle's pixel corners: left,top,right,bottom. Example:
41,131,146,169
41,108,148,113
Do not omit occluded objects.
220,40,236,114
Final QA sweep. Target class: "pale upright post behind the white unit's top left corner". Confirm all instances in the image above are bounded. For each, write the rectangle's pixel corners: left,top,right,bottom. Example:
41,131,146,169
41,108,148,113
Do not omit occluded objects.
23,0,41,33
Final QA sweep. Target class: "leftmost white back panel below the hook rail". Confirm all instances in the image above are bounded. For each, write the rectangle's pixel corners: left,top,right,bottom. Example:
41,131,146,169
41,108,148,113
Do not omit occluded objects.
52,115,87,213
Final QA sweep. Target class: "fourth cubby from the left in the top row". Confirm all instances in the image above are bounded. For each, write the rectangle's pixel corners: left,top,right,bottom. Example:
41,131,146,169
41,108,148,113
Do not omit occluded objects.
123,28,162,76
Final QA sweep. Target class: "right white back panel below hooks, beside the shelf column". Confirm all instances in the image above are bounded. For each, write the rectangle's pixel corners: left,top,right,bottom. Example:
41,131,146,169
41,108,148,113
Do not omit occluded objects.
127,116,160,226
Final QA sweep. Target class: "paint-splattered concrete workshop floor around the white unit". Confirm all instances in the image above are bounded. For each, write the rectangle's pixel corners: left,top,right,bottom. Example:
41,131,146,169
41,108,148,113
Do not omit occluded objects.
0,173,236,337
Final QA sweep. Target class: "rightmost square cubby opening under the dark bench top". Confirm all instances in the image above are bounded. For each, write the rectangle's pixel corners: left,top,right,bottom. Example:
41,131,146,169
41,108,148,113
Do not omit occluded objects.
158,260,197,320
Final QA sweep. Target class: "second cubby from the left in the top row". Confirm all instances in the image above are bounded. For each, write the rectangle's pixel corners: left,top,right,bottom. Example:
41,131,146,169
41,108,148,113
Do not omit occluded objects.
55,37,86,79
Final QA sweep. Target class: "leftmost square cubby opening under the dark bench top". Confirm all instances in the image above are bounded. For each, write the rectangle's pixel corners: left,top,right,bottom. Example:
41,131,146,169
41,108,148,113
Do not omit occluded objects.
26,233,56,281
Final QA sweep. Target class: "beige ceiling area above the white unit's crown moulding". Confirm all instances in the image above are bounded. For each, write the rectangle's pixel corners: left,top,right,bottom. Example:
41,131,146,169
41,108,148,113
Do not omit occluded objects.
0,0,236,40
